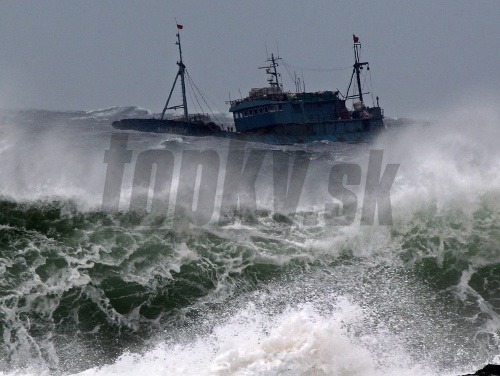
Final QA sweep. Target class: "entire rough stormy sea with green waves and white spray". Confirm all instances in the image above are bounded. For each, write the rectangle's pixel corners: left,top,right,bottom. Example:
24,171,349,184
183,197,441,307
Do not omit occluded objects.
0,106,500,376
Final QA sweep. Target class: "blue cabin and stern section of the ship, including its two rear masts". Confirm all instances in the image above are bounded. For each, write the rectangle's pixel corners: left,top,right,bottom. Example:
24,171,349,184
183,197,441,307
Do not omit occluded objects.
229,40,383,133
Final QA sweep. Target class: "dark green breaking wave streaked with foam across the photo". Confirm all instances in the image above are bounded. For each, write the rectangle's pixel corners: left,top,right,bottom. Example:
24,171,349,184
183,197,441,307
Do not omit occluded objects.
0,191,500,374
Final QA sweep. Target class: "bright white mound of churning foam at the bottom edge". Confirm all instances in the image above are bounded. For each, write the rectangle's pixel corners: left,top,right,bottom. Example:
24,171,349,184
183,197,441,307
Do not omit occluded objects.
74,299,428,376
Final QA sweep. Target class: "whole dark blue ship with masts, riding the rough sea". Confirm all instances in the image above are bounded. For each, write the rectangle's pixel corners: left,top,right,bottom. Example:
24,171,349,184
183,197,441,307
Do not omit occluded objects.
112,25,385,144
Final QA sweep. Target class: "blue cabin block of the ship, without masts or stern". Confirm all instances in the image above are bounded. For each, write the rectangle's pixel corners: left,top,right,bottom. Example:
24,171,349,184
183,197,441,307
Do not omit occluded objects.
229,87,352,132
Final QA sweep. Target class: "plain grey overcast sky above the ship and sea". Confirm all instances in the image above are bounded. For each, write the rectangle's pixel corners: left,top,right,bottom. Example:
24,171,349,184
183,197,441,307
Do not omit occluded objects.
0,0,500,117
